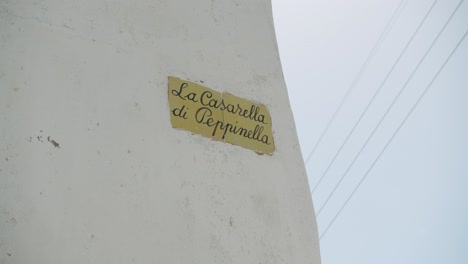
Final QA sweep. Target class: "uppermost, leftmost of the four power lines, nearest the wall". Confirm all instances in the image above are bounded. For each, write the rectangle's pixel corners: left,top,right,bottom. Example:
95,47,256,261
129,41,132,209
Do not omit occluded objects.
305,0,408,165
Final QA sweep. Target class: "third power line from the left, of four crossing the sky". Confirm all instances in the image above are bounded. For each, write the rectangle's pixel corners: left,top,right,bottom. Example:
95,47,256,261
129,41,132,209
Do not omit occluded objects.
317,0,464,216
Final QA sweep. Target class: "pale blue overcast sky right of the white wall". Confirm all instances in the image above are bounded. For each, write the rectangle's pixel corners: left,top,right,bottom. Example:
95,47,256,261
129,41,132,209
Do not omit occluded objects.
272,0,468,264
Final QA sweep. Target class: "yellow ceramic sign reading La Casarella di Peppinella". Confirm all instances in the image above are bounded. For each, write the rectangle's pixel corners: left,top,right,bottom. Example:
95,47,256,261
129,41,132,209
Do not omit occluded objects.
168,76,275,154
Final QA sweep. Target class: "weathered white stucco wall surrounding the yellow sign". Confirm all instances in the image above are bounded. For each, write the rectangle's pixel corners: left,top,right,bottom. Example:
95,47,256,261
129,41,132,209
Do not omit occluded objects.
0,0,320,264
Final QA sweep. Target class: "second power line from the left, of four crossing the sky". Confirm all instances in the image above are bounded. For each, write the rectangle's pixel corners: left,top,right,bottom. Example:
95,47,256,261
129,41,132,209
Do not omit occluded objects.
312,0,438,193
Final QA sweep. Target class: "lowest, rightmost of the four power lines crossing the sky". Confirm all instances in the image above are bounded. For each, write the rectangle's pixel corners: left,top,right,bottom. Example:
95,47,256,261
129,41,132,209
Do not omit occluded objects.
320,27,468,239
